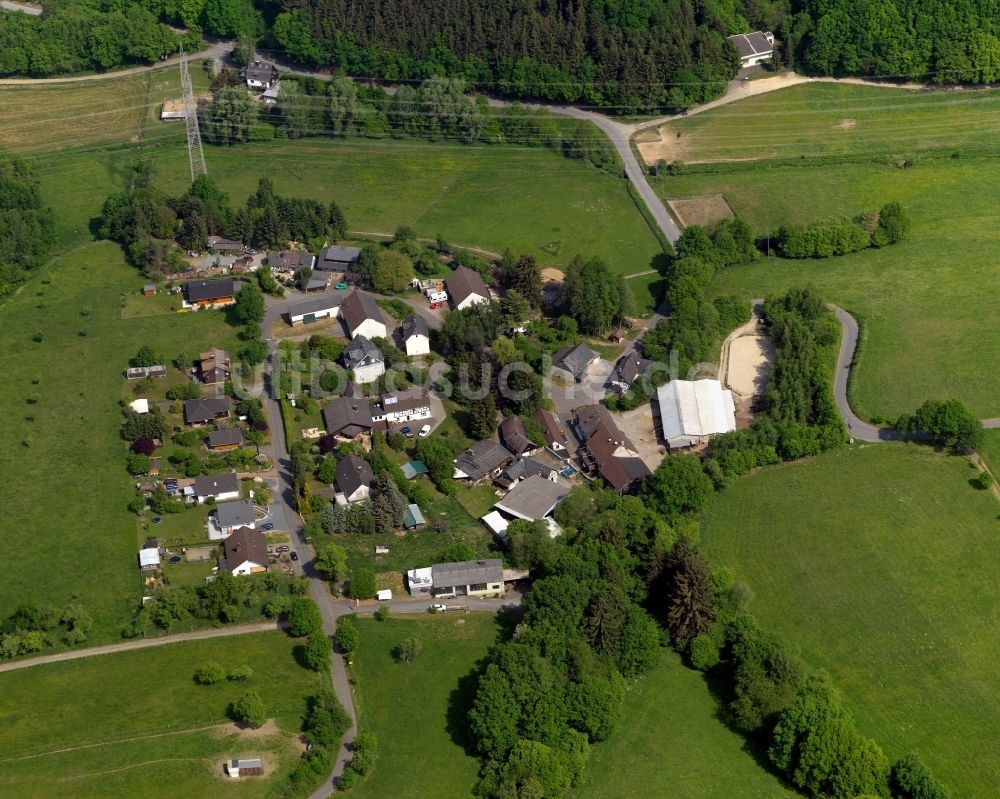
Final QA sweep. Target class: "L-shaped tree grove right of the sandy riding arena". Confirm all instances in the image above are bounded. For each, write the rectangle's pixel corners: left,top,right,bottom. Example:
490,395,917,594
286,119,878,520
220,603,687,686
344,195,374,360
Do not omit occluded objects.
705,288,846,478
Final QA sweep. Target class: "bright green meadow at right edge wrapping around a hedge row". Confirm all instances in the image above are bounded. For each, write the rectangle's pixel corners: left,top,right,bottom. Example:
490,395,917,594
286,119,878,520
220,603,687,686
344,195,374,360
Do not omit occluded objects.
657,159,1000,419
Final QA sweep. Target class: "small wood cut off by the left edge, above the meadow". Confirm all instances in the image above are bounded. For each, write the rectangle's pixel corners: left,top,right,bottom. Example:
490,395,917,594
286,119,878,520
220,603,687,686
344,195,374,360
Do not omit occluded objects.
0,152,52,298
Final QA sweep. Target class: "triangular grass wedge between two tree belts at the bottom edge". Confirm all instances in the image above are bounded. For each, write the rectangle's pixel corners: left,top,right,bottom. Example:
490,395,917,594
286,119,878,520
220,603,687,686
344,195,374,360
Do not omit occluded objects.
572,652,799,799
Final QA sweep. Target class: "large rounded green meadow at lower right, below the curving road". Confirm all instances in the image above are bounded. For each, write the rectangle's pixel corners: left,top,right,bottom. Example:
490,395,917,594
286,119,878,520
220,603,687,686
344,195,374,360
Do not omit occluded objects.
702,444,1000,797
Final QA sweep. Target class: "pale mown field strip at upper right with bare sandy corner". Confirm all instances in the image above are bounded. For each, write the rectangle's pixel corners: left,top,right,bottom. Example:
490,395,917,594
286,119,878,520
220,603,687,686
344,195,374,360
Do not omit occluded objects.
666,83,1000,163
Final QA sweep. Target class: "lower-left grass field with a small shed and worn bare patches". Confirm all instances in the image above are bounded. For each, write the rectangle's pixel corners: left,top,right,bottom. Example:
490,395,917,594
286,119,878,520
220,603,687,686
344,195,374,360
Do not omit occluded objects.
0,632,328,799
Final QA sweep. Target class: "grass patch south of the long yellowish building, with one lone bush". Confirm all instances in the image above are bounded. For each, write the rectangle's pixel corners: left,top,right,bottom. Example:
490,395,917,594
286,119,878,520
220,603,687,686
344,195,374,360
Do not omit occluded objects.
352,613,500,799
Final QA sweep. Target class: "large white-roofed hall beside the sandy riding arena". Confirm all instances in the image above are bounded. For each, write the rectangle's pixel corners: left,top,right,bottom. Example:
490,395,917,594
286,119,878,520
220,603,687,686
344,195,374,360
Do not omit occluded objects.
656,380,736,449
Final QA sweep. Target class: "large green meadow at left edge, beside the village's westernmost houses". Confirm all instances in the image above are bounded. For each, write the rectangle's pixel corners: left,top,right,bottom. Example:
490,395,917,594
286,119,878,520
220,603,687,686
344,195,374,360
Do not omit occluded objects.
0,243,237,641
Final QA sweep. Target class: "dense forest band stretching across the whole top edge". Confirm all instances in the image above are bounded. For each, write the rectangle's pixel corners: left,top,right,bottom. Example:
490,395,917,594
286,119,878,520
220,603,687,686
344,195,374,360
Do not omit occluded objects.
0,0,1000,100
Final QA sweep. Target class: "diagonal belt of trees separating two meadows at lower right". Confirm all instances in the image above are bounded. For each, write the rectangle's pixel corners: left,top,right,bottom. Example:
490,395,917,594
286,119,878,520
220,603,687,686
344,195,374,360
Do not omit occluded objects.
656,532,948,799
